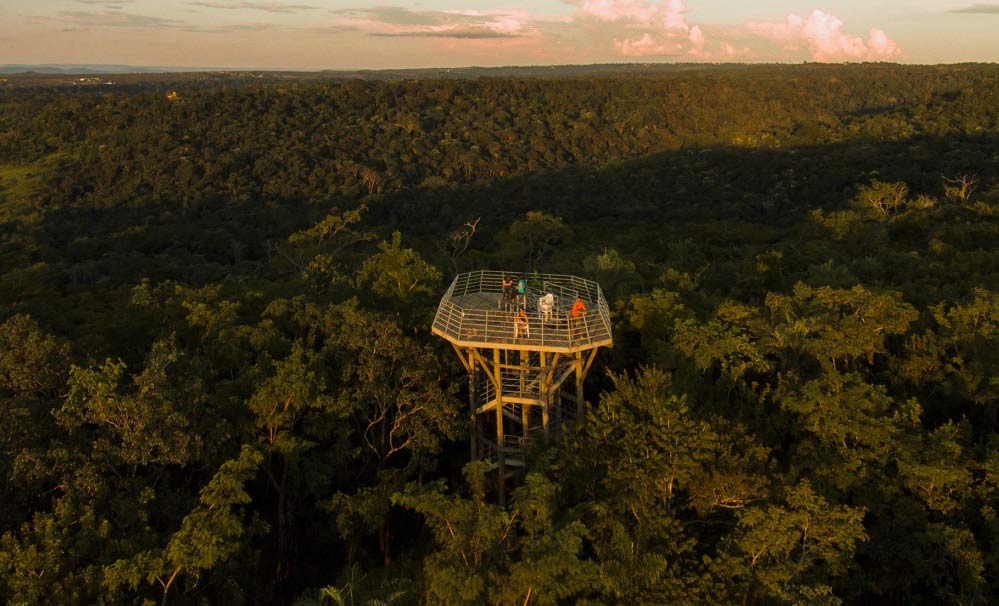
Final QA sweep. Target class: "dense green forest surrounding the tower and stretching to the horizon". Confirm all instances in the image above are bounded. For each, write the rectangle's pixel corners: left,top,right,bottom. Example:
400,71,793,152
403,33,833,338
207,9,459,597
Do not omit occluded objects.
0,65,999,606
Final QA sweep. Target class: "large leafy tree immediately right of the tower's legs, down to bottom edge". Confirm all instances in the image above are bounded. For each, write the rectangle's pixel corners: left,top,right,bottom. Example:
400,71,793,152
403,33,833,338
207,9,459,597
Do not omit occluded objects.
559,368,769,603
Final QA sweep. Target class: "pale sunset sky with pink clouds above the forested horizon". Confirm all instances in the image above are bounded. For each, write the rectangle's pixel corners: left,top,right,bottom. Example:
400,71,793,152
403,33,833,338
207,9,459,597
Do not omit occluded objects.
0,0,999,69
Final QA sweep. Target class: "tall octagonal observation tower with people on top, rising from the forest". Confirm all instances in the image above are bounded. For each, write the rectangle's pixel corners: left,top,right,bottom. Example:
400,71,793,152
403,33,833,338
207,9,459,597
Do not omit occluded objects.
433,271,613,501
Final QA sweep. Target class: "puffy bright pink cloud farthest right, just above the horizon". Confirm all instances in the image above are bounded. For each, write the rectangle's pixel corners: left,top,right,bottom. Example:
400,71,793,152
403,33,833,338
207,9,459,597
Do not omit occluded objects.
746,10,903,62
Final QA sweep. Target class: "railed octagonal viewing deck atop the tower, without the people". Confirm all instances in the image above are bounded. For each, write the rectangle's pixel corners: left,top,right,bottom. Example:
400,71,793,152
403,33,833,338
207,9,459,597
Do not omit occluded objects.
433,270,613,353
